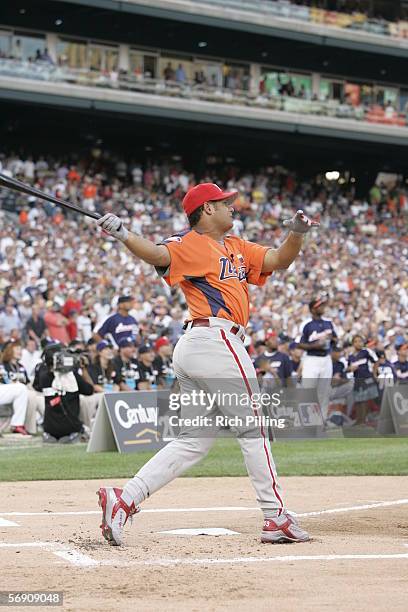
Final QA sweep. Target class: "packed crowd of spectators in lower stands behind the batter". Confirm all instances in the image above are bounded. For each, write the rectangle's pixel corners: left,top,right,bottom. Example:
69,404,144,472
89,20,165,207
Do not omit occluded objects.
0,150,408,441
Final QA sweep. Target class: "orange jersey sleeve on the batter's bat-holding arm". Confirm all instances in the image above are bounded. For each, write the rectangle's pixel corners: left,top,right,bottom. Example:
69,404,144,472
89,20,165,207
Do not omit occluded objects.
156,236,208,287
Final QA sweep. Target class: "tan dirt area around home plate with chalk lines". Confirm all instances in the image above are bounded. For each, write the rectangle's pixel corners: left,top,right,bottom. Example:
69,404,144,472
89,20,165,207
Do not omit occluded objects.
0,477,408,612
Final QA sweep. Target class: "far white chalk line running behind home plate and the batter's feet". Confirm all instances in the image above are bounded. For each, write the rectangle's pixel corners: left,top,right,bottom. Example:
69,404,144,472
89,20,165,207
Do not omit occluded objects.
0,499,408,518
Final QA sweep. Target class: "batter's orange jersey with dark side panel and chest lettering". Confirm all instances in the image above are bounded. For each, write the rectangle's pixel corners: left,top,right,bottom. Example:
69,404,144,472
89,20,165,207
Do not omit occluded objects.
158,230,270,326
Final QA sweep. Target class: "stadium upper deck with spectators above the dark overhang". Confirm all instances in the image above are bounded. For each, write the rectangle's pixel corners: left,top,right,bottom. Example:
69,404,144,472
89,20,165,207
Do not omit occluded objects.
0,0,408,145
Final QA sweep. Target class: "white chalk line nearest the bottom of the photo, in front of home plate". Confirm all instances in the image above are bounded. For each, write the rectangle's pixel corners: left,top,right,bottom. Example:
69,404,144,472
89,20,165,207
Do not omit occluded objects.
0,542,408,568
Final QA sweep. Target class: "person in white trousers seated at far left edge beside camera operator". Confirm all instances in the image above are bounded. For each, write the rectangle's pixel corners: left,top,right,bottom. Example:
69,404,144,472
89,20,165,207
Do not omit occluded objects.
1,340,44,434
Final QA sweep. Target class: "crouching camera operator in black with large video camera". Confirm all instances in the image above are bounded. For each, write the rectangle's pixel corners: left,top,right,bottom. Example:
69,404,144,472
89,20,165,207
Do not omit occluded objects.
33,343,94,444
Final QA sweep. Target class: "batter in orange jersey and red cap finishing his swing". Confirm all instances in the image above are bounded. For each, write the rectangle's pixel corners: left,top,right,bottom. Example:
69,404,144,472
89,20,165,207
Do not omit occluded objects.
98,183,319,545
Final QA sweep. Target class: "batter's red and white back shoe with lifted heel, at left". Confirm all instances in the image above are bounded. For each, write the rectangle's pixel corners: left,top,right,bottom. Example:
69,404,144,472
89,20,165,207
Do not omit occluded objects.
96,487,140,546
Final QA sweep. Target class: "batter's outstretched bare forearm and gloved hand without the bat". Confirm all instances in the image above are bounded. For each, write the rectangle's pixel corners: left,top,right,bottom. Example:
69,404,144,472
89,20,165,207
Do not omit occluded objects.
262,210,320,273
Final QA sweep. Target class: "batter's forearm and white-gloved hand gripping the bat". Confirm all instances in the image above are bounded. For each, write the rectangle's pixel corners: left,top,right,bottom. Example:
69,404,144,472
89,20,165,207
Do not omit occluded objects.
97,213,170,268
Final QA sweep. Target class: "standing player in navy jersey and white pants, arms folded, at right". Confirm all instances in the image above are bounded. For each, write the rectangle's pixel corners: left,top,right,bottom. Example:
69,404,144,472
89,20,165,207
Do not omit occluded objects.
298,297,337,421
